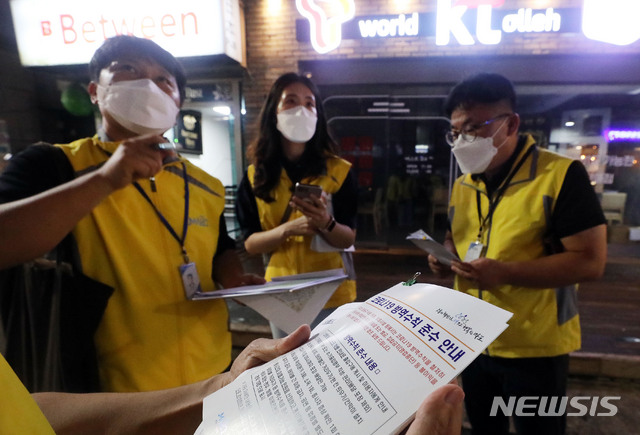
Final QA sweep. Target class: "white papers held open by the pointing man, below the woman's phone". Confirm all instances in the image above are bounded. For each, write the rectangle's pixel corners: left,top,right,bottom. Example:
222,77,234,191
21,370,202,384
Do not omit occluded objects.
192,269,347,333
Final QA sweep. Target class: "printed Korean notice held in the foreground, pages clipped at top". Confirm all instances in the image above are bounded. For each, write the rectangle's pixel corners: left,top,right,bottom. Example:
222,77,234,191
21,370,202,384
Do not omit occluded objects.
196,284,511,435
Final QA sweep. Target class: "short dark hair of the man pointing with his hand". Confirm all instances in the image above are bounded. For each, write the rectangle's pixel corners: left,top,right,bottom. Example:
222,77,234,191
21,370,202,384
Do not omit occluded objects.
89,35,187,103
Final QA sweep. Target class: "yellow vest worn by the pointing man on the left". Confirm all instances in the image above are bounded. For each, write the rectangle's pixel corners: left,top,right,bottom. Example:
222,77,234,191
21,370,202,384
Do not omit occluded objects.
60,136,231,391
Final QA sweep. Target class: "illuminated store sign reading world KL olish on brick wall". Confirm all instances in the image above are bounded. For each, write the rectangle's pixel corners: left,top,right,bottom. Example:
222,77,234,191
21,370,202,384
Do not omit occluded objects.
296,0,640,53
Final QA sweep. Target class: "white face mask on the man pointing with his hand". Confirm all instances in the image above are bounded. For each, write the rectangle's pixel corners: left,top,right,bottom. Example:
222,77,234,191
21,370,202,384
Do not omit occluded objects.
97,79,180,134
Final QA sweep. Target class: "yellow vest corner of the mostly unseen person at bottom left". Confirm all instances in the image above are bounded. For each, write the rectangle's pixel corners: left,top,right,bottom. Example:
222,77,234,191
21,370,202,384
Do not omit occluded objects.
0,355,54,435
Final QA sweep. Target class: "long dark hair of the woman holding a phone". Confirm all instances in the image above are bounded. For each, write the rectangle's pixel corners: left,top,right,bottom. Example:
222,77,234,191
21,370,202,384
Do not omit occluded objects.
247,73,337,202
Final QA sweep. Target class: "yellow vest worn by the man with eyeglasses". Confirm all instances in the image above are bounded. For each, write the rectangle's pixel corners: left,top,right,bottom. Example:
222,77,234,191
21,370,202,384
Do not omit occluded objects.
449,136,581,358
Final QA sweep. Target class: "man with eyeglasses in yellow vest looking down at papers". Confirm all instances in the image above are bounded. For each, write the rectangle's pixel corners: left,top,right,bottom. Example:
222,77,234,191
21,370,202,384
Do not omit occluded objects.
429,73,607,435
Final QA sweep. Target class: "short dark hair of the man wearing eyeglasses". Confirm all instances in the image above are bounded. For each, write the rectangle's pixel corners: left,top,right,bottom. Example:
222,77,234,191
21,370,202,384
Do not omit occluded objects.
444,73,516,117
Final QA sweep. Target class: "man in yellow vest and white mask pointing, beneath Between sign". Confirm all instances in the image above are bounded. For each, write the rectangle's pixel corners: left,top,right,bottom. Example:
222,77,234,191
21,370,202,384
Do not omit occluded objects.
0,35,264,391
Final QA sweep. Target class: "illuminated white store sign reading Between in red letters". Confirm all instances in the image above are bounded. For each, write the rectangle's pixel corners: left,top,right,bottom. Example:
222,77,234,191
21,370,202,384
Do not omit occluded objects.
10,0,243,66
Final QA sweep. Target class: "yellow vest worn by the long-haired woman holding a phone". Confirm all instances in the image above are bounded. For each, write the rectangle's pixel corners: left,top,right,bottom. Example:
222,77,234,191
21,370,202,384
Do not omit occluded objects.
247,156,356,308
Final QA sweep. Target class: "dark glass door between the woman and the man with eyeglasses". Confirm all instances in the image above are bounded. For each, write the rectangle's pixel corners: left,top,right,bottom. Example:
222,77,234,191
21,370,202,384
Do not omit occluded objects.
324,92,451,249
